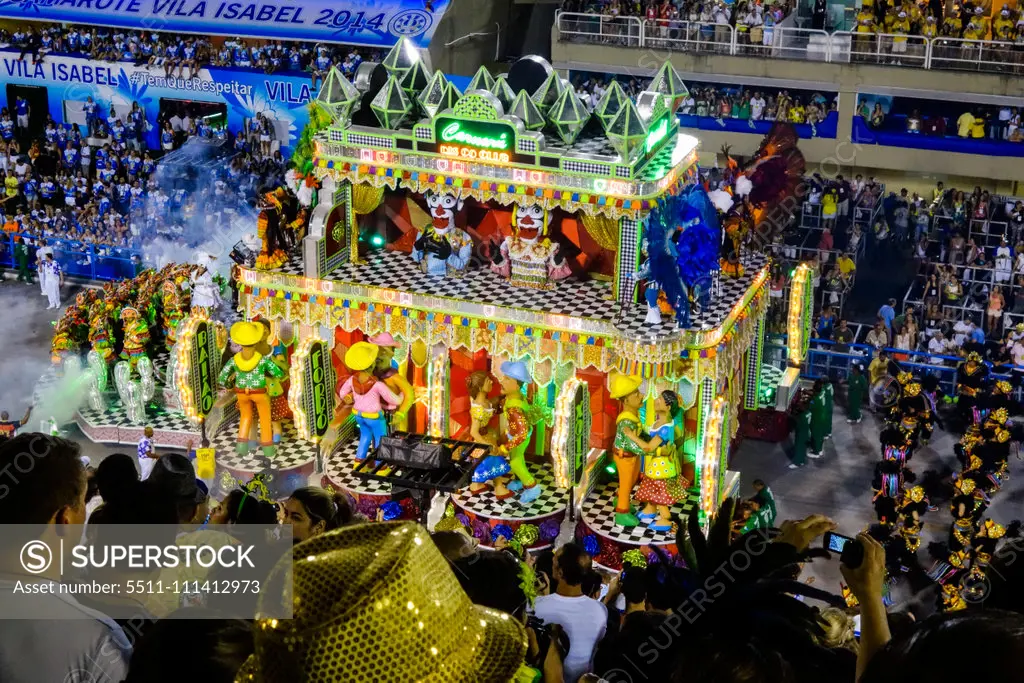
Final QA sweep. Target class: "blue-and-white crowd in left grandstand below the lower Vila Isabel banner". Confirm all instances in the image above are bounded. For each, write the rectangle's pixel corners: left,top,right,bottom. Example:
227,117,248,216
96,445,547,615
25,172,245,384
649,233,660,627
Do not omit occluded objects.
0,98,286,258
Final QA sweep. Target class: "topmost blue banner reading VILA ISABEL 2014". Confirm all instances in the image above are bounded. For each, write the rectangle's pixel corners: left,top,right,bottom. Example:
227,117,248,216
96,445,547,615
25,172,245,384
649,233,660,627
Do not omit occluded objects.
0,0,450,47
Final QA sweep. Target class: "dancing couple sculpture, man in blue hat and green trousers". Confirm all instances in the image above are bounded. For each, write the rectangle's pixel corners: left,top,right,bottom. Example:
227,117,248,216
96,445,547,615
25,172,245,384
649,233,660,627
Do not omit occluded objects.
466,360,542,505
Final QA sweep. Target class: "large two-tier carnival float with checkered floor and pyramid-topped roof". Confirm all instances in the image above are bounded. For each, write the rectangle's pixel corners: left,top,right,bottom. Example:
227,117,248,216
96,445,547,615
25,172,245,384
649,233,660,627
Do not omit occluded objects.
232,41,798,568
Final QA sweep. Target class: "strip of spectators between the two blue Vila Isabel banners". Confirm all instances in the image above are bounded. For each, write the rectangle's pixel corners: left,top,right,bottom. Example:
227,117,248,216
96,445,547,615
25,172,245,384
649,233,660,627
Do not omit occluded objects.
0,24,382,81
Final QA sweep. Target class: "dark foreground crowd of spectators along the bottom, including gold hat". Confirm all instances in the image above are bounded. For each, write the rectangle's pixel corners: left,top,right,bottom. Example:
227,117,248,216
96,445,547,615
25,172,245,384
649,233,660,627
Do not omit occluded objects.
6,434,1024,683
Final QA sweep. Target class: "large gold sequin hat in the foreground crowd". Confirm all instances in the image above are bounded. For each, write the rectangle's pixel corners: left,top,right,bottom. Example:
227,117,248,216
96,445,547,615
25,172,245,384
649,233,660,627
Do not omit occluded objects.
234,522,527,683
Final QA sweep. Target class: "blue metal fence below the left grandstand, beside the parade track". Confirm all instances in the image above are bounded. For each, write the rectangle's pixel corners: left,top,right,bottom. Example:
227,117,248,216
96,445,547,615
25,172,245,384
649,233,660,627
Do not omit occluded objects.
0,232,142,281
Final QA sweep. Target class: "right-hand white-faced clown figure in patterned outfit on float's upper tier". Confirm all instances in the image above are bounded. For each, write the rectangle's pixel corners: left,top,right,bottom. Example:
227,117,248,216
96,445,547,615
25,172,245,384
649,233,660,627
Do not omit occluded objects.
490,205,572,290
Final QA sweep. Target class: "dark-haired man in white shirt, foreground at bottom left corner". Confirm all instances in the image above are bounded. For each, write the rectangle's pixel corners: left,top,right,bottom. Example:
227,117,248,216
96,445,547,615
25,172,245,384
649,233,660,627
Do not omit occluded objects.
0,433,131,683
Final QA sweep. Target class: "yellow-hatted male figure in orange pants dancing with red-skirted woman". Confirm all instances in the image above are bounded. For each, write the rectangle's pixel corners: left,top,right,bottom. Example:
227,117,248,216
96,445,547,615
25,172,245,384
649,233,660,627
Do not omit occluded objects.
609,375,650,528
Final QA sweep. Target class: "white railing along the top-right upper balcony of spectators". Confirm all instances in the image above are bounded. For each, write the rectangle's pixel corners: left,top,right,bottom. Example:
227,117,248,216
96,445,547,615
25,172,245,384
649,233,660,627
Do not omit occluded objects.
555,12,1024,74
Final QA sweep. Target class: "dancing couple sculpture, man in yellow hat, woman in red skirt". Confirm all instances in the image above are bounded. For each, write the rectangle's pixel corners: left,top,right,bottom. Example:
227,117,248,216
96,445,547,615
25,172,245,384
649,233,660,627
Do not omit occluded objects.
610,375,690,531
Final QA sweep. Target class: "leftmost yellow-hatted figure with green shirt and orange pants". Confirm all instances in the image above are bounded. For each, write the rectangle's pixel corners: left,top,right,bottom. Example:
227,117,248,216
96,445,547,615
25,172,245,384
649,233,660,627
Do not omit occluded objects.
218,322,285,458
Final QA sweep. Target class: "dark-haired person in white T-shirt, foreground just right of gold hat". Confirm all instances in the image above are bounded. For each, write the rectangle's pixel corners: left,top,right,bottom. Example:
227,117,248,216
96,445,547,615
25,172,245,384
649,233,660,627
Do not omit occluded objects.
534,543,608,681
